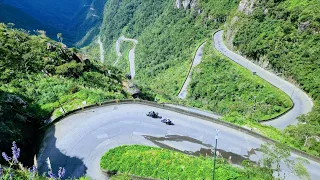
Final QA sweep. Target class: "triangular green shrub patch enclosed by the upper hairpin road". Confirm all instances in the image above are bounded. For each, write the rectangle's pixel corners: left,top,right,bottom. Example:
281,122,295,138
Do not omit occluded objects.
187,43,293,125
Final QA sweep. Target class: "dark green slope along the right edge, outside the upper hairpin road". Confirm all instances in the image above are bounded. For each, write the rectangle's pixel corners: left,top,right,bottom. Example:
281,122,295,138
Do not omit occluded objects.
232,0,320,156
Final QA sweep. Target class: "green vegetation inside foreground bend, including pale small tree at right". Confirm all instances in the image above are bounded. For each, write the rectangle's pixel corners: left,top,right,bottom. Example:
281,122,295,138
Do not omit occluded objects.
100,144,308,180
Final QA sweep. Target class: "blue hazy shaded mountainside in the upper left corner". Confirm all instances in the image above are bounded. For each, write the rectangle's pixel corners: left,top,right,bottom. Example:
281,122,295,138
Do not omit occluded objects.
0,0,106,46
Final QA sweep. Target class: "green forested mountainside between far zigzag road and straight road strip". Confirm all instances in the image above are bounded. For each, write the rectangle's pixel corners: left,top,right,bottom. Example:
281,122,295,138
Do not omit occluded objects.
100,0,237,99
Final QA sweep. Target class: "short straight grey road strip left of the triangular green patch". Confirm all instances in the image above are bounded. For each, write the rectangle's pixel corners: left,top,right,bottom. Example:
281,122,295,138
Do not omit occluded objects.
178,43,206,99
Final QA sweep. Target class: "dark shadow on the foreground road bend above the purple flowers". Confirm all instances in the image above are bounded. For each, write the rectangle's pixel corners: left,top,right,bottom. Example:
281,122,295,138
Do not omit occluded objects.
37,126,87,178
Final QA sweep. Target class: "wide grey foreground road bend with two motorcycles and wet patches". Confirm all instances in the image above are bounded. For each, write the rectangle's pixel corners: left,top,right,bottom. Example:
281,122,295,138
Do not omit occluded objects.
38,104,320,180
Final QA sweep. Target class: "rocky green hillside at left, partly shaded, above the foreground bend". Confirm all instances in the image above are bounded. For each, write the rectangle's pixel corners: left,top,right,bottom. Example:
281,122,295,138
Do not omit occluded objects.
0,24,127,164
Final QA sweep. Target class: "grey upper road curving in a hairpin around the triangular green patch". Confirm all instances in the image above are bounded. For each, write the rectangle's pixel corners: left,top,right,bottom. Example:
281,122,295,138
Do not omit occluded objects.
213,31,313,130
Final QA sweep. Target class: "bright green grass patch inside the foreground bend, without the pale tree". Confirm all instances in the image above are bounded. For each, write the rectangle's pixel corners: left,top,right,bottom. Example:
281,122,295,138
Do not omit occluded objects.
100,145,272,180
